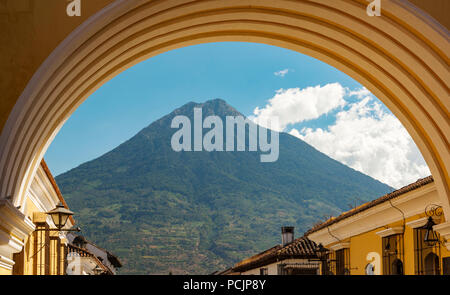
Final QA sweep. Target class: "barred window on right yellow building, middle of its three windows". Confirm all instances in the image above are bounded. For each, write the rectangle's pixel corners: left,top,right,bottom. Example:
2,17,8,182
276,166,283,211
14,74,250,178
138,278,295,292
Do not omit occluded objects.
382,234,404,275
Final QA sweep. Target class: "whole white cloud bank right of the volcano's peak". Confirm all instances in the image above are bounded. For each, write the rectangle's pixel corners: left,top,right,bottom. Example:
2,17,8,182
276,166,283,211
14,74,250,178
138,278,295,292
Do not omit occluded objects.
250,83,430,188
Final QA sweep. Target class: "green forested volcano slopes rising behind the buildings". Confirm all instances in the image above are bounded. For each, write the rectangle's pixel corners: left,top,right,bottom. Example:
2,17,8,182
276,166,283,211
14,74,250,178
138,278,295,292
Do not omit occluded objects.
56,99,392,274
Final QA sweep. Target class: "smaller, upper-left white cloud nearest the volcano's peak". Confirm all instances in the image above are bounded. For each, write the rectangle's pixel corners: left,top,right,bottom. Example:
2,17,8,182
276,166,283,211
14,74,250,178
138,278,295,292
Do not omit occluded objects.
250,83,346,131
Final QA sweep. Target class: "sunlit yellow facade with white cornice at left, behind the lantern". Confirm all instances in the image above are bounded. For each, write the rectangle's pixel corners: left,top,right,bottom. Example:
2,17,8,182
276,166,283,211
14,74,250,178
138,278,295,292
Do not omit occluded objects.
0,162,74,275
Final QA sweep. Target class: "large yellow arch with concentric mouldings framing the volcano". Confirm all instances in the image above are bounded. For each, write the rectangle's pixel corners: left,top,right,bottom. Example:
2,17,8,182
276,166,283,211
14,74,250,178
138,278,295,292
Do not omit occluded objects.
0,0,450,228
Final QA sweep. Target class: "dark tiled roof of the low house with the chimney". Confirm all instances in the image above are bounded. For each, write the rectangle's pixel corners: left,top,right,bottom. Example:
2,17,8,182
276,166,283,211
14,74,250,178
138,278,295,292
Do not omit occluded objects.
232,237,317,272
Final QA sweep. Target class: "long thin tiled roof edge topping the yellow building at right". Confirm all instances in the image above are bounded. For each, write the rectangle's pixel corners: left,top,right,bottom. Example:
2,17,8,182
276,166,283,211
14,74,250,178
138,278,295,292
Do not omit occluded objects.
305,175,434,236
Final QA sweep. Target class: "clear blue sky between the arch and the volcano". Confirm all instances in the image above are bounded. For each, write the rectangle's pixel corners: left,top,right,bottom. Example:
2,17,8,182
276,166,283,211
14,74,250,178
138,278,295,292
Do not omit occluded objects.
45,42,423,188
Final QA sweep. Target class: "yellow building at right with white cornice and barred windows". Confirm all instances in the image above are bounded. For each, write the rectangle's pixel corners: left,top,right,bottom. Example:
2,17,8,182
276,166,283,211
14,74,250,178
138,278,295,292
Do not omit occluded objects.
305,176,450,275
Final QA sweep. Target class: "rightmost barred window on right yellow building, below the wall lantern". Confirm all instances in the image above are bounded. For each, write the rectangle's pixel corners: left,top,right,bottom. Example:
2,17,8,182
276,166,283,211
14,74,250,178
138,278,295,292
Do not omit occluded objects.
414,228,441,275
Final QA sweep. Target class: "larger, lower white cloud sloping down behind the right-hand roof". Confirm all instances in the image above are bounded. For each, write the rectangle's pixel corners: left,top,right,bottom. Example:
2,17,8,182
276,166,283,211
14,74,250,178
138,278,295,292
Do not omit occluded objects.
289,97,430,188
